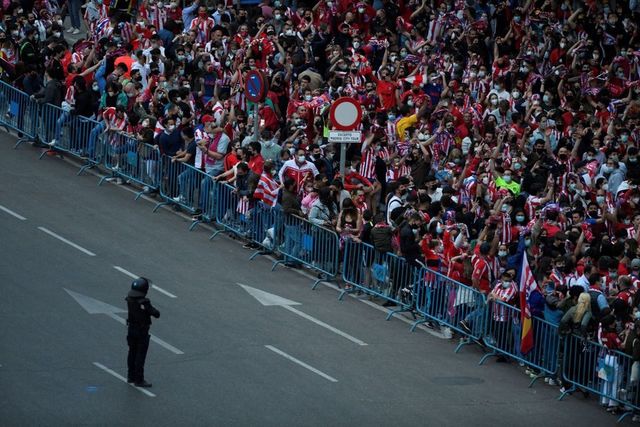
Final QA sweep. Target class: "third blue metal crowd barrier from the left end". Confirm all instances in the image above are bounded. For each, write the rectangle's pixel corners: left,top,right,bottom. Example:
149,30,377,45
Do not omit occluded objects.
98,133,161,200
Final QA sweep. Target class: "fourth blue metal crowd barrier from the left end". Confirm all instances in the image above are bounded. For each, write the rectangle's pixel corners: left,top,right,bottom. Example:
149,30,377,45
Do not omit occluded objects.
155,150,203,213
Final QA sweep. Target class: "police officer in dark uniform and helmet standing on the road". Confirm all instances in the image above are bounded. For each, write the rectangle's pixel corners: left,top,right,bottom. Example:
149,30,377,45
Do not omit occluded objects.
125,277,160,387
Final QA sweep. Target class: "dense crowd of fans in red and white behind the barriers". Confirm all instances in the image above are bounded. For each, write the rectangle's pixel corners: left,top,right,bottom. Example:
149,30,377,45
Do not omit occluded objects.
0,0,640,412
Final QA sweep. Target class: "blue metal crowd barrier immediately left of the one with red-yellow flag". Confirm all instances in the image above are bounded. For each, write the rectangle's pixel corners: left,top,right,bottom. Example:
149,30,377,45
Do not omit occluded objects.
411,268,487,353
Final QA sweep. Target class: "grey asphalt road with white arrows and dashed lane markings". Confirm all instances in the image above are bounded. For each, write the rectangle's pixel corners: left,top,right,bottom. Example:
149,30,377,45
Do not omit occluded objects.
0,134,615,426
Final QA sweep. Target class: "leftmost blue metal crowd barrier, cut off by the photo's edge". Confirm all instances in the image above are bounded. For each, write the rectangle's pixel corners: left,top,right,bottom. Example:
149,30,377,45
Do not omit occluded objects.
0,81,39,148
